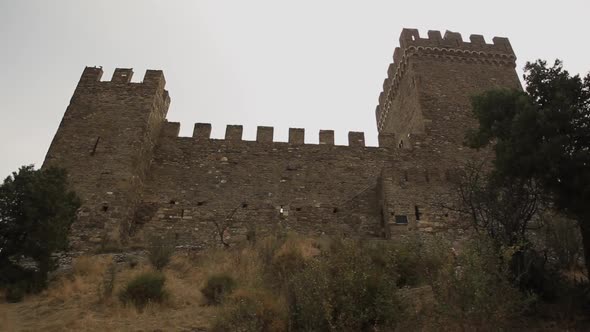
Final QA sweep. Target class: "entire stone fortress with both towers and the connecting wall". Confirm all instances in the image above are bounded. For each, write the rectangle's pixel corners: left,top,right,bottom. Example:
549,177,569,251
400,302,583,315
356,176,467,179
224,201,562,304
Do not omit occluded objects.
44,29,521,250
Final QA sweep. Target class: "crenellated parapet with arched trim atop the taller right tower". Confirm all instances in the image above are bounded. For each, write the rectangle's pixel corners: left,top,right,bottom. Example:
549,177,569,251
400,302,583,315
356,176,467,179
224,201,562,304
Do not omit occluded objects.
375,29,516,132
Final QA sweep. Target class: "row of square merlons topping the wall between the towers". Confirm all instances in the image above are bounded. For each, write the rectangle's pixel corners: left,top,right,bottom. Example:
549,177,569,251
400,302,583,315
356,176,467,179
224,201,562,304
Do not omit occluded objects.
162,122,365,147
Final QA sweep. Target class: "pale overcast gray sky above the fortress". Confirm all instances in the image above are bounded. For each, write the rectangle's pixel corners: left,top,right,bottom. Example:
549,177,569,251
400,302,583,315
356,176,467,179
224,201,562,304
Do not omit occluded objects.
0,0,590,178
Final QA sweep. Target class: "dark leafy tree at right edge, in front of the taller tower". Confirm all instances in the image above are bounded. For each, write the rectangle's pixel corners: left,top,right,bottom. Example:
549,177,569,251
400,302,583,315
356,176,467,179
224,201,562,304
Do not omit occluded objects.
467,60,590,271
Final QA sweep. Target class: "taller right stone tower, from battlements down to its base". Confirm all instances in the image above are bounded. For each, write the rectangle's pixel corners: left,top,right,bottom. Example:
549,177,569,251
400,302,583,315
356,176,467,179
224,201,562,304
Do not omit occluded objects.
376,29,521,235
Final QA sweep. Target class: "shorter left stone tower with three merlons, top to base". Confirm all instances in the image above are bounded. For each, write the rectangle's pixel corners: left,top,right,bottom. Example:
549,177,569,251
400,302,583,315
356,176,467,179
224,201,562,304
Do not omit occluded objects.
43,67,170,248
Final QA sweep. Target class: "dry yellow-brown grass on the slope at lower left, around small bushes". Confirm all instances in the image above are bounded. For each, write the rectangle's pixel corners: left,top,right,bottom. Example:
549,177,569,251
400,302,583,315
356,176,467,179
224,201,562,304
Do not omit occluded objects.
0,236,319,331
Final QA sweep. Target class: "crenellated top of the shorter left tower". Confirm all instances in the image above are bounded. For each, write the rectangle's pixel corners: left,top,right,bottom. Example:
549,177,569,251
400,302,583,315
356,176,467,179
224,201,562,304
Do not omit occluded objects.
78,67,166,89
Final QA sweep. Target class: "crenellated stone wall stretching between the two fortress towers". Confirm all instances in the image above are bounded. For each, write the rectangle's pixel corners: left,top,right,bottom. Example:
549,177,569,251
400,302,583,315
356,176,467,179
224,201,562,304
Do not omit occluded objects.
135,124,391,246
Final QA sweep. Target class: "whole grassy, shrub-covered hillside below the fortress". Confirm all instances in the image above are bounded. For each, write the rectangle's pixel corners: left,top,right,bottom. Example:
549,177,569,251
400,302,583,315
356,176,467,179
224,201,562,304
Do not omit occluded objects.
0,235,590,331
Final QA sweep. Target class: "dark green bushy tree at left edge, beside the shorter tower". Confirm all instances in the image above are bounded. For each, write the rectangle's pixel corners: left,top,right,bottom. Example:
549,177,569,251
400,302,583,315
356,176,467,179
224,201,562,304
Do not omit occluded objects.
0,166,80,291
